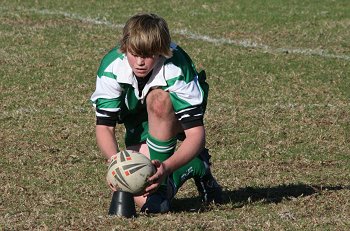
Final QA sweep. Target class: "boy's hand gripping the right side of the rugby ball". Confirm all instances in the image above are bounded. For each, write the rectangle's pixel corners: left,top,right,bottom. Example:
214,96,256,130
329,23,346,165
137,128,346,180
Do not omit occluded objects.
143,160,170,197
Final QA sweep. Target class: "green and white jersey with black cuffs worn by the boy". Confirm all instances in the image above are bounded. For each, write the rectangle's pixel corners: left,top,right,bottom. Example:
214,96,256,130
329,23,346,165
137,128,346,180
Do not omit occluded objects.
91,44,207,145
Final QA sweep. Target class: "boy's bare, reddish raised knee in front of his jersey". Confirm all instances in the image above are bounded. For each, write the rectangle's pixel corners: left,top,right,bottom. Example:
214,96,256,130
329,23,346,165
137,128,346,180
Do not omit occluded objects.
146,89,174,118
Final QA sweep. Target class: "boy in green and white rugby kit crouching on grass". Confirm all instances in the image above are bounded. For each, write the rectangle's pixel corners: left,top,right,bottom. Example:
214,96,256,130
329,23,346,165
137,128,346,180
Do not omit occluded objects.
91,14,222,213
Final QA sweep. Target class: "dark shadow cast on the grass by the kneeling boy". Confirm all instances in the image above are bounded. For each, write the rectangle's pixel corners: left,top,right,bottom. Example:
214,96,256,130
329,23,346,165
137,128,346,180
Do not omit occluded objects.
173,184,350,212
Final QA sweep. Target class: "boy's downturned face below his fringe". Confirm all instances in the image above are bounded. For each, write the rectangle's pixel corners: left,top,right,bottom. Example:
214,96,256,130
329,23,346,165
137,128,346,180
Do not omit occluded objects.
126,52,160,78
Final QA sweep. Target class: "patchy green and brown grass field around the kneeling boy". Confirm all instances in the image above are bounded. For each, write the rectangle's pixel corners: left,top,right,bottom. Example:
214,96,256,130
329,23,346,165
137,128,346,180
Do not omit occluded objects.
0,0,350,230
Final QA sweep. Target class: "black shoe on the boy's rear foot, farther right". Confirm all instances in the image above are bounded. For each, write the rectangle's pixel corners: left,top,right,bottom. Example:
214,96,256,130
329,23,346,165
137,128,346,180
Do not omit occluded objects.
194,149,223,204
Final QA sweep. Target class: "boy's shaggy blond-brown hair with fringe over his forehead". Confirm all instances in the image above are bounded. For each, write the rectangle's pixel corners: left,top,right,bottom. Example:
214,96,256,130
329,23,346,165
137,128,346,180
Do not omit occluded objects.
119,14,172,58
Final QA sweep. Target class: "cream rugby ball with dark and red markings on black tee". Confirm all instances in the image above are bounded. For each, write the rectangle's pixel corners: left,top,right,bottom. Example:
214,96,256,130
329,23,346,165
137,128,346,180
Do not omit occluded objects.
107,150,156,195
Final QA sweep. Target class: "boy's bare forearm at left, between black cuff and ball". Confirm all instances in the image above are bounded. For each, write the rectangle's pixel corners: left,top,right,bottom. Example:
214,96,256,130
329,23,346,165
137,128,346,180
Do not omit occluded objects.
96,125,119,159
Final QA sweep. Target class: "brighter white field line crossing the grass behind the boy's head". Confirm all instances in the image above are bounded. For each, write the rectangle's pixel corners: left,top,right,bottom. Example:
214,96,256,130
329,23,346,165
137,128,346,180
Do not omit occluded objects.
1,8,350,60
